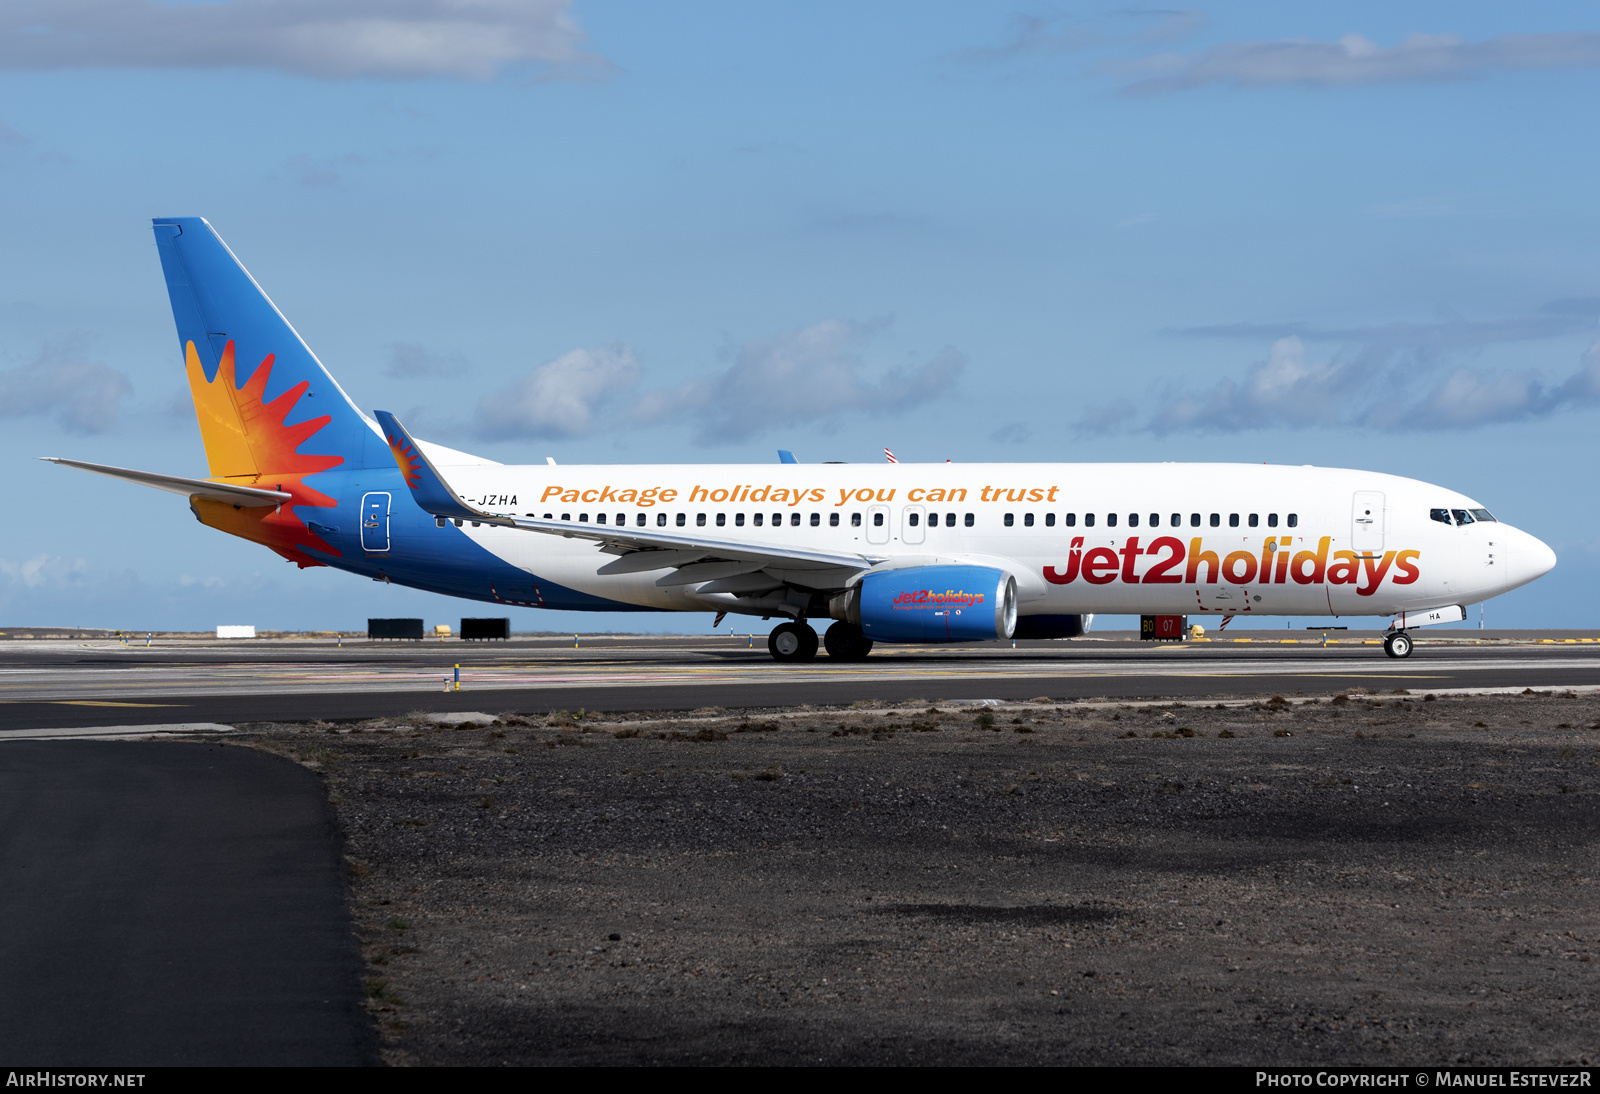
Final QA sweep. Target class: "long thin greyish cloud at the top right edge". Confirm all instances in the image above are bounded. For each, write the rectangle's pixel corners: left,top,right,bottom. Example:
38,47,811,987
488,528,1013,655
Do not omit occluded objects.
1106,30,1600,94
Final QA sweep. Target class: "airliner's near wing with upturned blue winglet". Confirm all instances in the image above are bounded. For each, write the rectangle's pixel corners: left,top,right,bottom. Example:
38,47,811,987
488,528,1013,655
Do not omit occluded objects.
374,411,886,581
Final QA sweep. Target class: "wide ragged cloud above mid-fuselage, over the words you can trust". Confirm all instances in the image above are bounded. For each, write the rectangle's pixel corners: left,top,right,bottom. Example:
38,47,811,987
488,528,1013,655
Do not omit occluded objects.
632,320,963,445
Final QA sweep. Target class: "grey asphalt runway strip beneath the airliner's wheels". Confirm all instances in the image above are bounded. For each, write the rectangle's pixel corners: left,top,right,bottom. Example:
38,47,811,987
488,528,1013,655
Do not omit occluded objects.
0,630,1600,736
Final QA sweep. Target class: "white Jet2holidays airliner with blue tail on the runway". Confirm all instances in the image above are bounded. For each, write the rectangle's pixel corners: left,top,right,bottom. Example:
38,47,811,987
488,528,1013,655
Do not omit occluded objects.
40,218,1555,661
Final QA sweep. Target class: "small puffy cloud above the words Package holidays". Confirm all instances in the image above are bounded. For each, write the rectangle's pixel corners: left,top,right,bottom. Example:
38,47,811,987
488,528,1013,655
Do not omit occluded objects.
477,342,638,440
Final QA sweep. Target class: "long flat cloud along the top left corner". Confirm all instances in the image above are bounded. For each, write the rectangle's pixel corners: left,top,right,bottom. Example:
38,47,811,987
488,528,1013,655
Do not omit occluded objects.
0,0,606,80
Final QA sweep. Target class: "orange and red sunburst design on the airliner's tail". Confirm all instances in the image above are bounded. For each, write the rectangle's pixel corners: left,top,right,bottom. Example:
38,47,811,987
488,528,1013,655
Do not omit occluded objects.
184,341,344,568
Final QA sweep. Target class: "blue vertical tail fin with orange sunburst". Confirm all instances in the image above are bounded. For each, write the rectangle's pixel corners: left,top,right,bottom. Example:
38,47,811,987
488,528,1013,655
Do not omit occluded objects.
154,216,392,478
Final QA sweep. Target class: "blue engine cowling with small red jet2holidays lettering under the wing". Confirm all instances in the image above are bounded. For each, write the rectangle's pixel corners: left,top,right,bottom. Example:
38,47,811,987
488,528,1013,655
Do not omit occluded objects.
832,566,1016,641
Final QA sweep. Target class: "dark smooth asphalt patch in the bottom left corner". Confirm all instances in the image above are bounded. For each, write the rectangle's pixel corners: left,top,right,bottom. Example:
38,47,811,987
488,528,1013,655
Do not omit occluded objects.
0,741,378,1068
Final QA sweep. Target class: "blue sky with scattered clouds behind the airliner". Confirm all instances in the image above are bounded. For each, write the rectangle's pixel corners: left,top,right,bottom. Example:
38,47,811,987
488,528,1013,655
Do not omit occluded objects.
0,0,1600,630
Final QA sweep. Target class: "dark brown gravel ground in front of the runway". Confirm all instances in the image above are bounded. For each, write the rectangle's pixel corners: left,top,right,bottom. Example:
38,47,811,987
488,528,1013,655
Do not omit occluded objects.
243,691,1600,1065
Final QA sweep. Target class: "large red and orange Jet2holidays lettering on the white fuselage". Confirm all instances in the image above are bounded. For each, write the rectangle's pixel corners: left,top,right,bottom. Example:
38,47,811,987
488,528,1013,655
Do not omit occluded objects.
1045,536,1422,597
